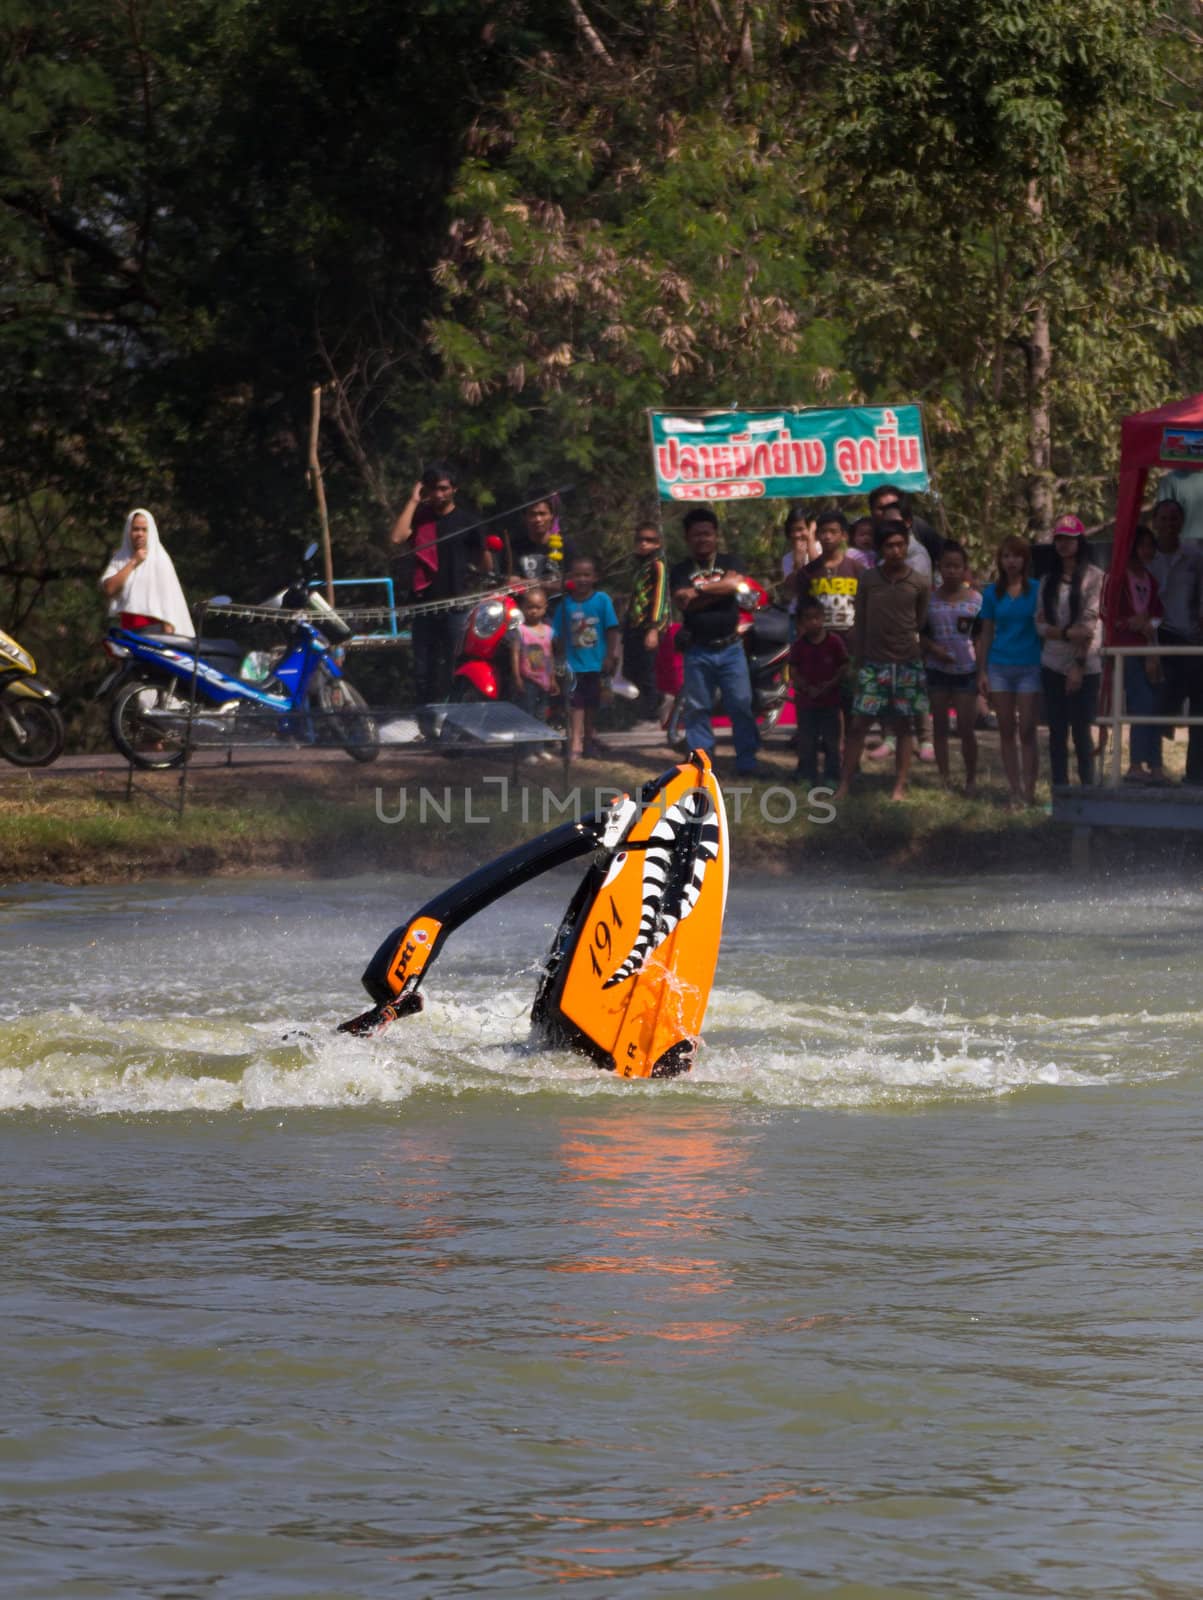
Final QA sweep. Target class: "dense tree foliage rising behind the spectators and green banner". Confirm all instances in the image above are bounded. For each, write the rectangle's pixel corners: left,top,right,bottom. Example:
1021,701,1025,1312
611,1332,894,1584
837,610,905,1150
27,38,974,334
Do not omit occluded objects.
0,0,1203,713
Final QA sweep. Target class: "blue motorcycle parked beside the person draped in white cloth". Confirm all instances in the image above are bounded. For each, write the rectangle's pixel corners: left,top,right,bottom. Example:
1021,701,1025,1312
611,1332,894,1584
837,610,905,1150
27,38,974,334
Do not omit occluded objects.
99,552,381,770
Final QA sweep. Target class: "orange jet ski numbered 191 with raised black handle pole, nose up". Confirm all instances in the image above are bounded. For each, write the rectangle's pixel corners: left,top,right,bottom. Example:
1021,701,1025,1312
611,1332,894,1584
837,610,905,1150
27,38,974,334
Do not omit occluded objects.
339,752,728,1078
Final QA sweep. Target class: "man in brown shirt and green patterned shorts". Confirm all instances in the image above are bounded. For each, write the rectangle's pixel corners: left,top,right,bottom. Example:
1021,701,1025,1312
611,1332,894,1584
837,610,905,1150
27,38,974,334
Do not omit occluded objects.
835,523,931,800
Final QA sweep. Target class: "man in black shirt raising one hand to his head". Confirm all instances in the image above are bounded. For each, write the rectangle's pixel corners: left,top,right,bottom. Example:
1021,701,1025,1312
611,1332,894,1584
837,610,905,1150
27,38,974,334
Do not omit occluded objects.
389,466,493,706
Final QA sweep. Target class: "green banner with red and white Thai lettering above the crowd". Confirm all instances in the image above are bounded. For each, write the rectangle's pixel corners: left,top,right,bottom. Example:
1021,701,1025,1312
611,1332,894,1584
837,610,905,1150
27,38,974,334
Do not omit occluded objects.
648,405,928,501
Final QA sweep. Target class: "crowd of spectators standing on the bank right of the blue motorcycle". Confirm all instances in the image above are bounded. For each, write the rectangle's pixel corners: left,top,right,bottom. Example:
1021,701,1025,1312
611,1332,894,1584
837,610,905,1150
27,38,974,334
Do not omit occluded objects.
392,466,1203,793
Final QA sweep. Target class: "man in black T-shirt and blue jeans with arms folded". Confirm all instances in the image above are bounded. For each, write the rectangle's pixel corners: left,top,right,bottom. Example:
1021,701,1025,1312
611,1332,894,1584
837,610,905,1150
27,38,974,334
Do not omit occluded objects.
669,506,761,778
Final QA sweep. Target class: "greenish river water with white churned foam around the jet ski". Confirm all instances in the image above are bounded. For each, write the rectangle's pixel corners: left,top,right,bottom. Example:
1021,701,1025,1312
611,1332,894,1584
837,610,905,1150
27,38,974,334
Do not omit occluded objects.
0,877,1203,1600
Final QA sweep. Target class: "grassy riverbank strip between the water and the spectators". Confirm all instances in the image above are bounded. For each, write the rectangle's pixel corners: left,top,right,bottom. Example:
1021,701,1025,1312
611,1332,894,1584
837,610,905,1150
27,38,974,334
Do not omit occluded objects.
0,752,1182,883
